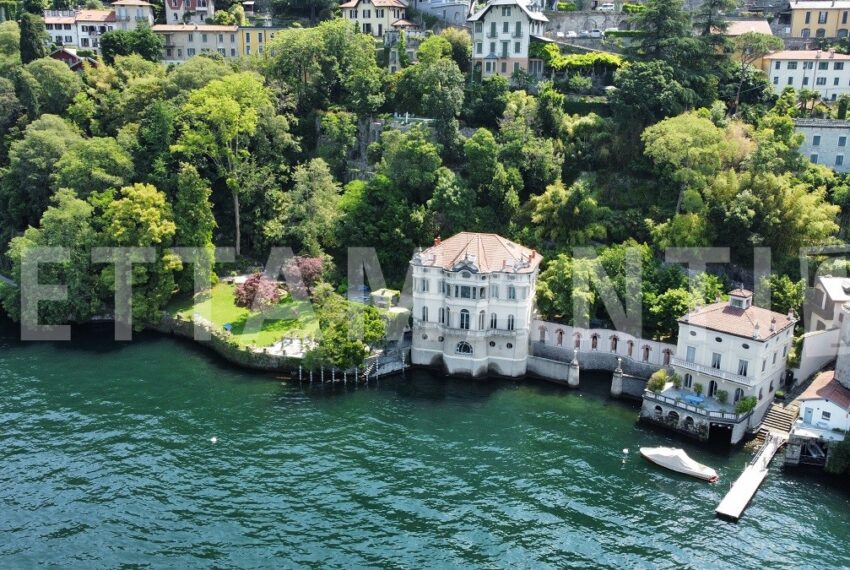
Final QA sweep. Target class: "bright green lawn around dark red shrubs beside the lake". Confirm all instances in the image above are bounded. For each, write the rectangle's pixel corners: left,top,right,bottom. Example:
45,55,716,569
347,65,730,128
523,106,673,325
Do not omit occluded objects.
168,283,319,347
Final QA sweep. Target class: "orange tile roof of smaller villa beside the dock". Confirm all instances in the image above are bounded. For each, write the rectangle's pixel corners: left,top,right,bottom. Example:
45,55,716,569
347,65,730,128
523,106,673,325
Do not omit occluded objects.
679,301,794,340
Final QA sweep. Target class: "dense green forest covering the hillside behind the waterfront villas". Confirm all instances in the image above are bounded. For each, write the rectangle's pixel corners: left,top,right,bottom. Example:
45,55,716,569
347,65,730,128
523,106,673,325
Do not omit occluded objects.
0,0,850,344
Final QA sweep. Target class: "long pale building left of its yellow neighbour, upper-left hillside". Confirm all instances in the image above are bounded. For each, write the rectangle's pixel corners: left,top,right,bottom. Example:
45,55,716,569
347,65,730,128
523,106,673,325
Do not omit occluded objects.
153,24,238,63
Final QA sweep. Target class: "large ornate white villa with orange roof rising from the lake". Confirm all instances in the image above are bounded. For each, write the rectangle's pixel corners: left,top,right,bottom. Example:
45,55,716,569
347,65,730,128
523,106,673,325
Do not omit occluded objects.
410,232,542,377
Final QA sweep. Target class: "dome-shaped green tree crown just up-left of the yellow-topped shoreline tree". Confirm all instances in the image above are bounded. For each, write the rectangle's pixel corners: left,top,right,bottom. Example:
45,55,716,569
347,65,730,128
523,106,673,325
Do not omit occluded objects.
51,136,133,198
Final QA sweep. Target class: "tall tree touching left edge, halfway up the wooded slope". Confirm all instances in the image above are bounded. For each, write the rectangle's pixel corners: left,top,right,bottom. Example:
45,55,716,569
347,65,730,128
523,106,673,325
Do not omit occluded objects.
0,115,81,231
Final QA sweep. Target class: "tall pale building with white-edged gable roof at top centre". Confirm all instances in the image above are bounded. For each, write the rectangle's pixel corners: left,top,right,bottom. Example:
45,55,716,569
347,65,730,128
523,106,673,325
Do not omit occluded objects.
469,0,549,77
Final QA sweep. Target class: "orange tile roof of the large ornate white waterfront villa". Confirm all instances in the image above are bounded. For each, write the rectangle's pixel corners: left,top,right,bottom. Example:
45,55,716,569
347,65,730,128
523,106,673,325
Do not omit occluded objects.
414,232,543,273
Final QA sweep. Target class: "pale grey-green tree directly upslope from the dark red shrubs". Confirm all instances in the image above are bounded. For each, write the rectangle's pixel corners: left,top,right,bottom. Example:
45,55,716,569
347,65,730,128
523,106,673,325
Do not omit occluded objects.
283,158,342,257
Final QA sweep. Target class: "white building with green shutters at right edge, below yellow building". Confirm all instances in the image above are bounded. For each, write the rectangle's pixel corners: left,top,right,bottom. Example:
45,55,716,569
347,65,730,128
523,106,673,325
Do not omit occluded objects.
762,50,850,101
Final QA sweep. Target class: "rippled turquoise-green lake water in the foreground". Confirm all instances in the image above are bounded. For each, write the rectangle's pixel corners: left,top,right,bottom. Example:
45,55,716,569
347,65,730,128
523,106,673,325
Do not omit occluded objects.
0,318,850,568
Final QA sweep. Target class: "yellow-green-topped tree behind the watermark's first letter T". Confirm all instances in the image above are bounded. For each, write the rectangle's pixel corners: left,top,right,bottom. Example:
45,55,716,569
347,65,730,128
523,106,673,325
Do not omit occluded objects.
100,184,182,327
